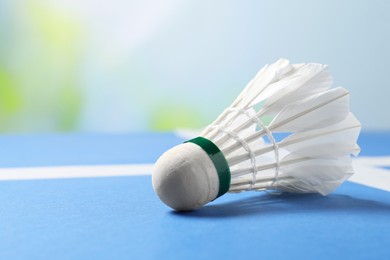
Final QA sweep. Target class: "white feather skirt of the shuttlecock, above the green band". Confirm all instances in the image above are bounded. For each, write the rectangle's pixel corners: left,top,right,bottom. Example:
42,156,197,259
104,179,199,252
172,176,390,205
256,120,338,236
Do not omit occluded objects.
201,59,360,195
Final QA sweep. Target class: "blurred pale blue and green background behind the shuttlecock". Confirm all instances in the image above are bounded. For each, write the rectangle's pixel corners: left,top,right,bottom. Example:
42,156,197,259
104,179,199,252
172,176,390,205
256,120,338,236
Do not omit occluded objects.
0,0,390,133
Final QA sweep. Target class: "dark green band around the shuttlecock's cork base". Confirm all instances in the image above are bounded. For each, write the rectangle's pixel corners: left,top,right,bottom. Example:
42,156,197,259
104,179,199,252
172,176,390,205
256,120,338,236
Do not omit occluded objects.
186,136,230,198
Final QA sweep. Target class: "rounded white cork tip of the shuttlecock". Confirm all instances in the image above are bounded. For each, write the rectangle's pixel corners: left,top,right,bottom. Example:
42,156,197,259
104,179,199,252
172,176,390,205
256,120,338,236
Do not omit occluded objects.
152,143,219,211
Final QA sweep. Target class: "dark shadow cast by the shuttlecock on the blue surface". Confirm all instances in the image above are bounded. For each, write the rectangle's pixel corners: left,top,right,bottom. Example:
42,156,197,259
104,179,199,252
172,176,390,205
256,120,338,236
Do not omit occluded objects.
172,194,390,218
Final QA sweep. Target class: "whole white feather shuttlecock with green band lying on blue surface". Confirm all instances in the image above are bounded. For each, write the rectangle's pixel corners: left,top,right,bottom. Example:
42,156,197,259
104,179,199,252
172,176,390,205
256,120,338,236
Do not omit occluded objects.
152,59,361,210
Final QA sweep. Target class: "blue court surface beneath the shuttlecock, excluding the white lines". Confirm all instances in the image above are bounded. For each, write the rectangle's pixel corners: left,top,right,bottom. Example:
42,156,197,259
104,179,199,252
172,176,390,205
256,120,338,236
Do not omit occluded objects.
0,132,390,259
